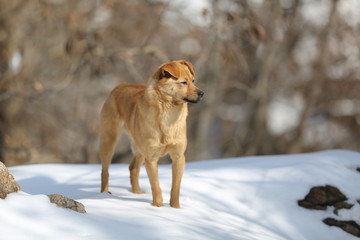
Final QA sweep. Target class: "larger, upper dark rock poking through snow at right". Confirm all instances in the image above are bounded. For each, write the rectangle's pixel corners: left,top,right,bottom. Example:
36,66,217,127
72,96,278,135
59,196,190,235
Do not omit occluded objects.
298,185,347,210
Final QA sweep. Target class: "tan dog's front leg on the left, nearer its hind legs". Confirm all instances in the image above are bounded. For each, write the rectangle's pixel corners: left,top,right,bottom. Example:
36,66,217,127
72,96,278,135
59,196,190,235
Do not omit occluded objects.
145,159,164,207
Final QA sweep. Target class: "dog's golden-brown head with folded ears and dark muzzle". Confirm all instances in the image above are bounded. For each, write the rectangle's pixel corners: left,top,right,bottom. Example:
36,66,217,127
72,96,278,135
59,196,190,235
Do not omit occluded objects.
153,60,204,104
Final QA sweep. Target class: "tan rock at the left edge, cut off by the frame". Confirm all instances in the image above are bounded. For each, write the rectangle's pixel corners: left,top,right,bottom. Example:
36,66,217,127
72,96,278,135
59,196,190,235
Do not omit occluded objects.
0,162,21,199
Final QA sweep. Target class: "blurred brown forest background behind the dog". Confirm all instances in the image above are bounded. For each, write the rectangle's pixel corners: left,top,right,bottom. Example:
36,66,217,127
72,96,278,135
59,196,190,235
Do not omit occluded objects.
0,0,360,166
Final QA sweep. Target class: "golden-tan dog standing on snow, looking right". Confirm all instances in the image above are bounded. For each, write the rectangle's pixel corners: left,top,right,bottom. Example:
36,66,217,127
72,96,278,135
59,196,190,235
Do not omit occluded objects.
99,60,204,208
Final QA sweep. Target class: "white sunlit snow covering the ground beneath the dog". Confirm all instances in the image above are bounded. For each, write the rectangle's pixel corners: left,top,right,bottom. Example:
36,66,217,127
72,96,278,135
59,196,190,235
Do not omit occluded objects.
0,150,360,240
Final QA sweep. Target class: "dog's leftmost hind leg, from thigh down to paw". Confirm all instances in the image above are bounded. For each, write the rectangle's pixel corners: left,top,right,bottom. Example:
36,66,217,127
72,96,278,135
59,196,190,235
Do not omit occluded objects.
99,98,123,192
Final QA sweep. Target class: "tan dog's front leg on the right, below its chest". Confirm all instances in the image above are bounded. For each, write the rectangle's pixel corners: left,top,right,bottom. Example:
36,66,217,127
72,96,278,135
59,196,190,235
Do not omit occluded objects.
170,154,185,208
